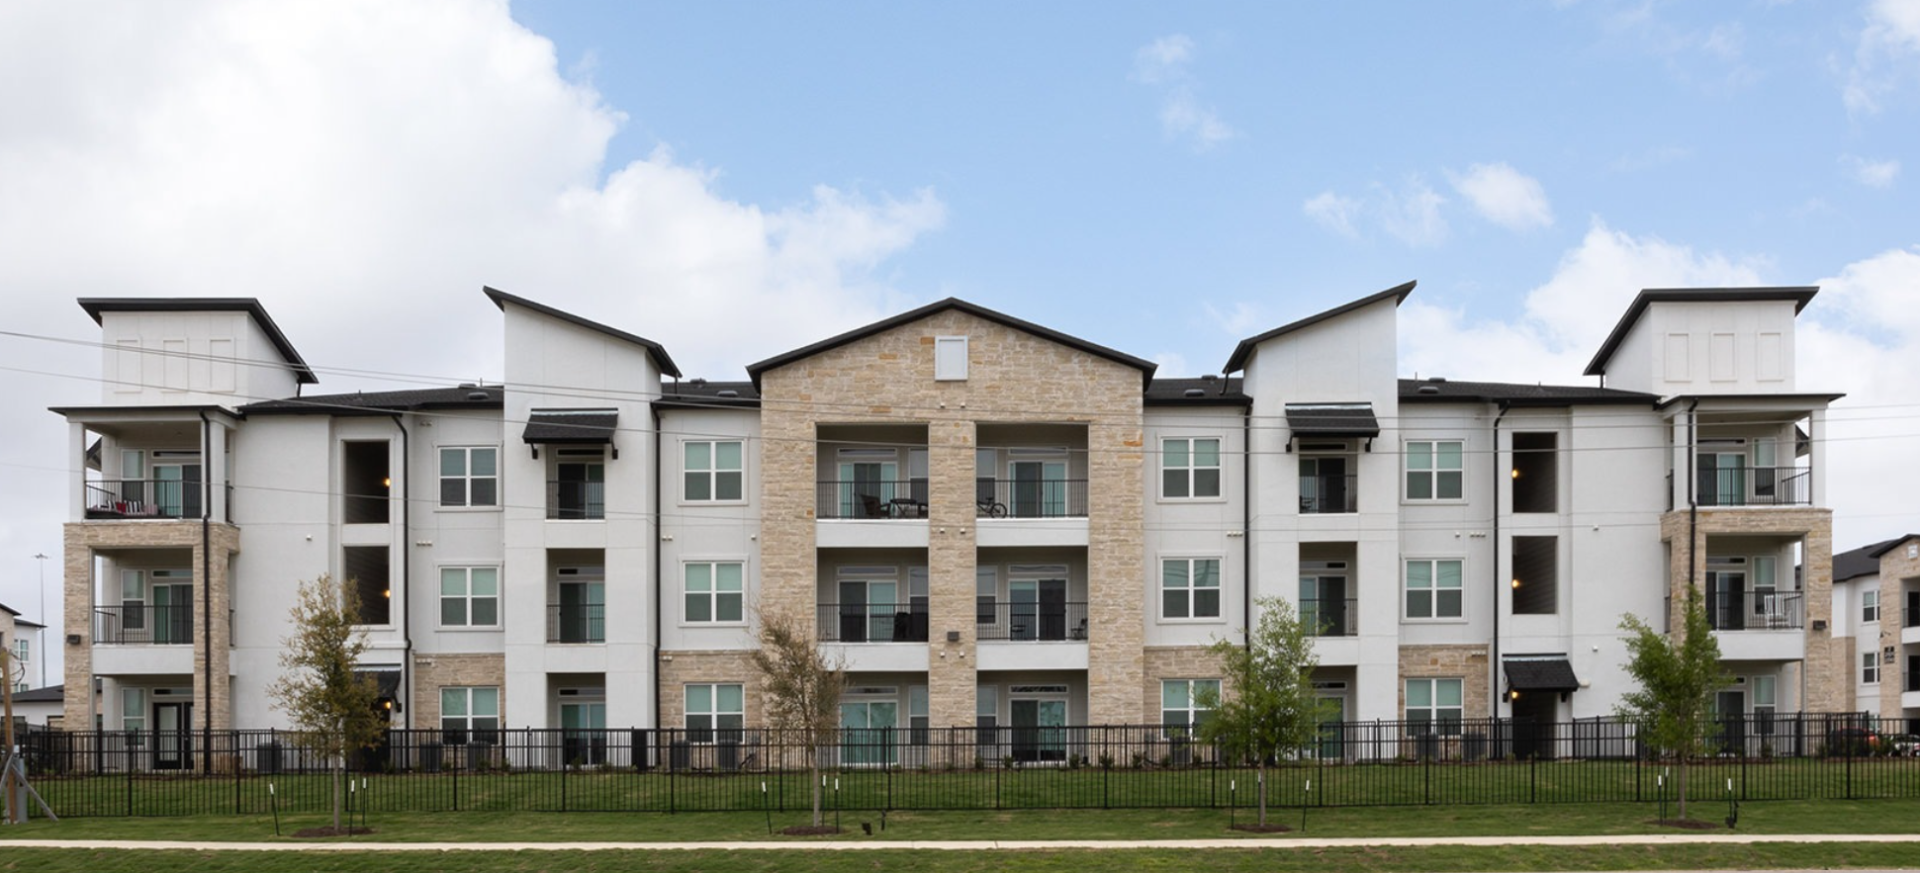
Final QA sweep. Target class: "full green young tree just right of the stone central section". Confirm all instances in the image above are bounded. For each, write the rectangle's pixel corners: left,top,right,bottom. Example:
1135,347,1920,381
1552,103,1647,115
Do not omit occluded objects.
1196,597,1321,827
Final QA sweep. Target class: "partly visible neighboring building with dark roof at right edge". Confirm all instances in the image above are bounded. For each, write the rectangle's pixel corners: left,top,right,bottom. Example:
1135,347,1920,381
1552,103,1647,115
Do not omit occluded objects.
1834,533,1920,733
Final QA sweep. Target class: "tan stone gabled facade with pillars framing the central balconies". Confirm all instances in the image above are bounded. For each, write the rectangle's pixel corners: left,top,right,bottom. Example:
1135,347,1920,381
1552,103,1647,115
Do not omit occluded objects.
752,309,1146,725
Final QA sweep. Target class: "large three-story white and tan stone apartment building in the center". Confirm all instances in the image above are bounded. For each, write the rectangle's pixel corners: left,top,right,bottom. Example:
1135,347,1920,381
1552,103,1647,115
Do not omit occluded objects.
56,289,1847,758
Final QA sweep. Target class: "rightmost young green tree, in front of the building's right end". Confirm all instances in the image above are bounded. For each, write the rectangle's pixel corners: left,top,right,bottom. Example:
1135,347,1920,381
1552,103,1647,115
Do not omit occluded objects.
1615,589,1730,821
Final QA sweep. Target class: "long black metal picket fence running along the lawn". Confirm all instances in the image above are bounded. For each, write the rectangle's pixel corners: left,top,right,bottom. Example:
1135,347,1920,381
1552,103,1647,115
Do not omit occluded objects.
23,716,1920,815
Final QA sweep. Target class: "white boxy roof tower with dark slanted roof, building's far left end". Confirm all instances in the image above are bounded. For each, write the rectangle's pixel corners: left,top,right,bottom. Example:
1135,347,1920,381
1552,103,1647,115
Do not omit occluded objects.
81,297,319,407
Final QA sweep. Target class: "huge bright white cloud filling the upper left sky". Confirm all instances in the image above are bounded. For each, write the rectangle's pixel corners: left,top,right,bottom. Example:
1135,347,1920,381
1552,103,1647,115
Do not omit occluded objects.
0,0,945,648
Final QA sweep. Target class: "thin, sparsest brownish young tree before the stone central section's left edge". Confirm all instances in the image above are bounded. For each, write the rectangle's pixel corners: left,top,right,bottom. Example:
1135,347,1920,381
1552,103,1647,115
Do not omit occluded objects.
753,612,847,827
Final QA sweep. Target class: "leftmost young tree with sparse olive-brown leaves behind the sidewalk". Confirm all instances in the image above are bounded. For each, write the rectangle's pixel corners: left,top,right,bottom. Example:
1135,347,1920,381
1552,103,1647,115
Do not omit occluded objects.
267,576,380,831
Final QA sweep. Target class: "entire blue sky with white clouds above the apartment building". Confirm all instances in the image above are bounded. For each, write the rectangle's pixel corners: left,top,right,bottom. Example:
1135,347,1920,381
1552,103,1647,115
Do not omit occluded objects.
0,0,1920,683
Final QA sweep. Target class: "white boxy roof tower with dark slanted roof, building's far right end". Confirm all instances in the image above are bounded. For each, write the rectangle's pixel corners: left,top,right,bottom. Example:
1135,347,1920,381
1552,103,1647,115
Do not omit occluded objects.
1586,288,1818,397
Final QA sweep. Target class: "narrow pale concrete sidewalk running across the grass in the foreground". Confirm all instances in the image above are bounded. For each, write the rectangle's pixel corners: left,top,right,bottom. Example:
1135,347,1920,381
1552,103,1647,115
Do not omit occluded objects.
0,831,1920,858
